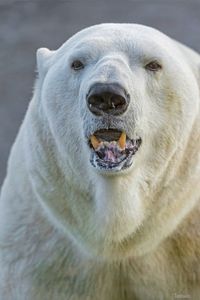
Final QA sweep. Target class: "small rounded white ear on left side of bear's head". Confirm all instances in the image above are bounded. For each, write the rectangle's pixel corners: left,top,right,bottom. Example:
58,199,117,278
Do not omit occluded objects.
36,48,54,75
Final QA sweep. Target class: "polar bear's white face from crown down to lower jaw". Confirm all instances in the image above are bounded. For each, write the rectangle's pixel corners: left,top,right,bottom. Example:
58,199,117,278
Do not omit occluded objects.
39,25,197,175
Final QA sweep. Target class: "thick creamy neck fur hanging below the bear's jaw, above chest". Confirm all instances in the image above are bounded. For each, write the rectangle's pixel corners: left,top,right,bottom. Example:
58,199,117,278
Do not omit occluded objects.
16,99,200,257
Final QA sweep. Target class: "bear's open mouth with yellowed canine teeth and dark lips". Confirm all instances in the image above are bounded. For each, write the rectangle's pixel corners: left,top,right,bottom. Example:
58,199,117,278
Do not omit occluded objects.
89,129,142,171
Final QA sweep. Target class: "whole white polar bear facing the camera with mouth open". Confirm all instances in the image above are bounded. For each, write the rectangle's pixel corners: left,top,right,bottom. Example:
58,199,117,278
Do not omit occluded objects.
0,24,200,300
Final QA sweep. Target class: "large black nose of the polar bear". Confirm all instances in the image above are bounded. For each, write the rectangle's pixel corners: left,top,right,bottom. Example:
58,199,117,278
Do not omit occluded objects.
87,83,130,116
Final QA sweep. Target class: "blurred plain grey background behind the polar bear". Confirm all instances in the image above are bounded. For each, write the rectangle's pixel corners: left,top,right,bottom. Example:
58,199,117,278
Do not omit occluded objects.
0,0,200,185
